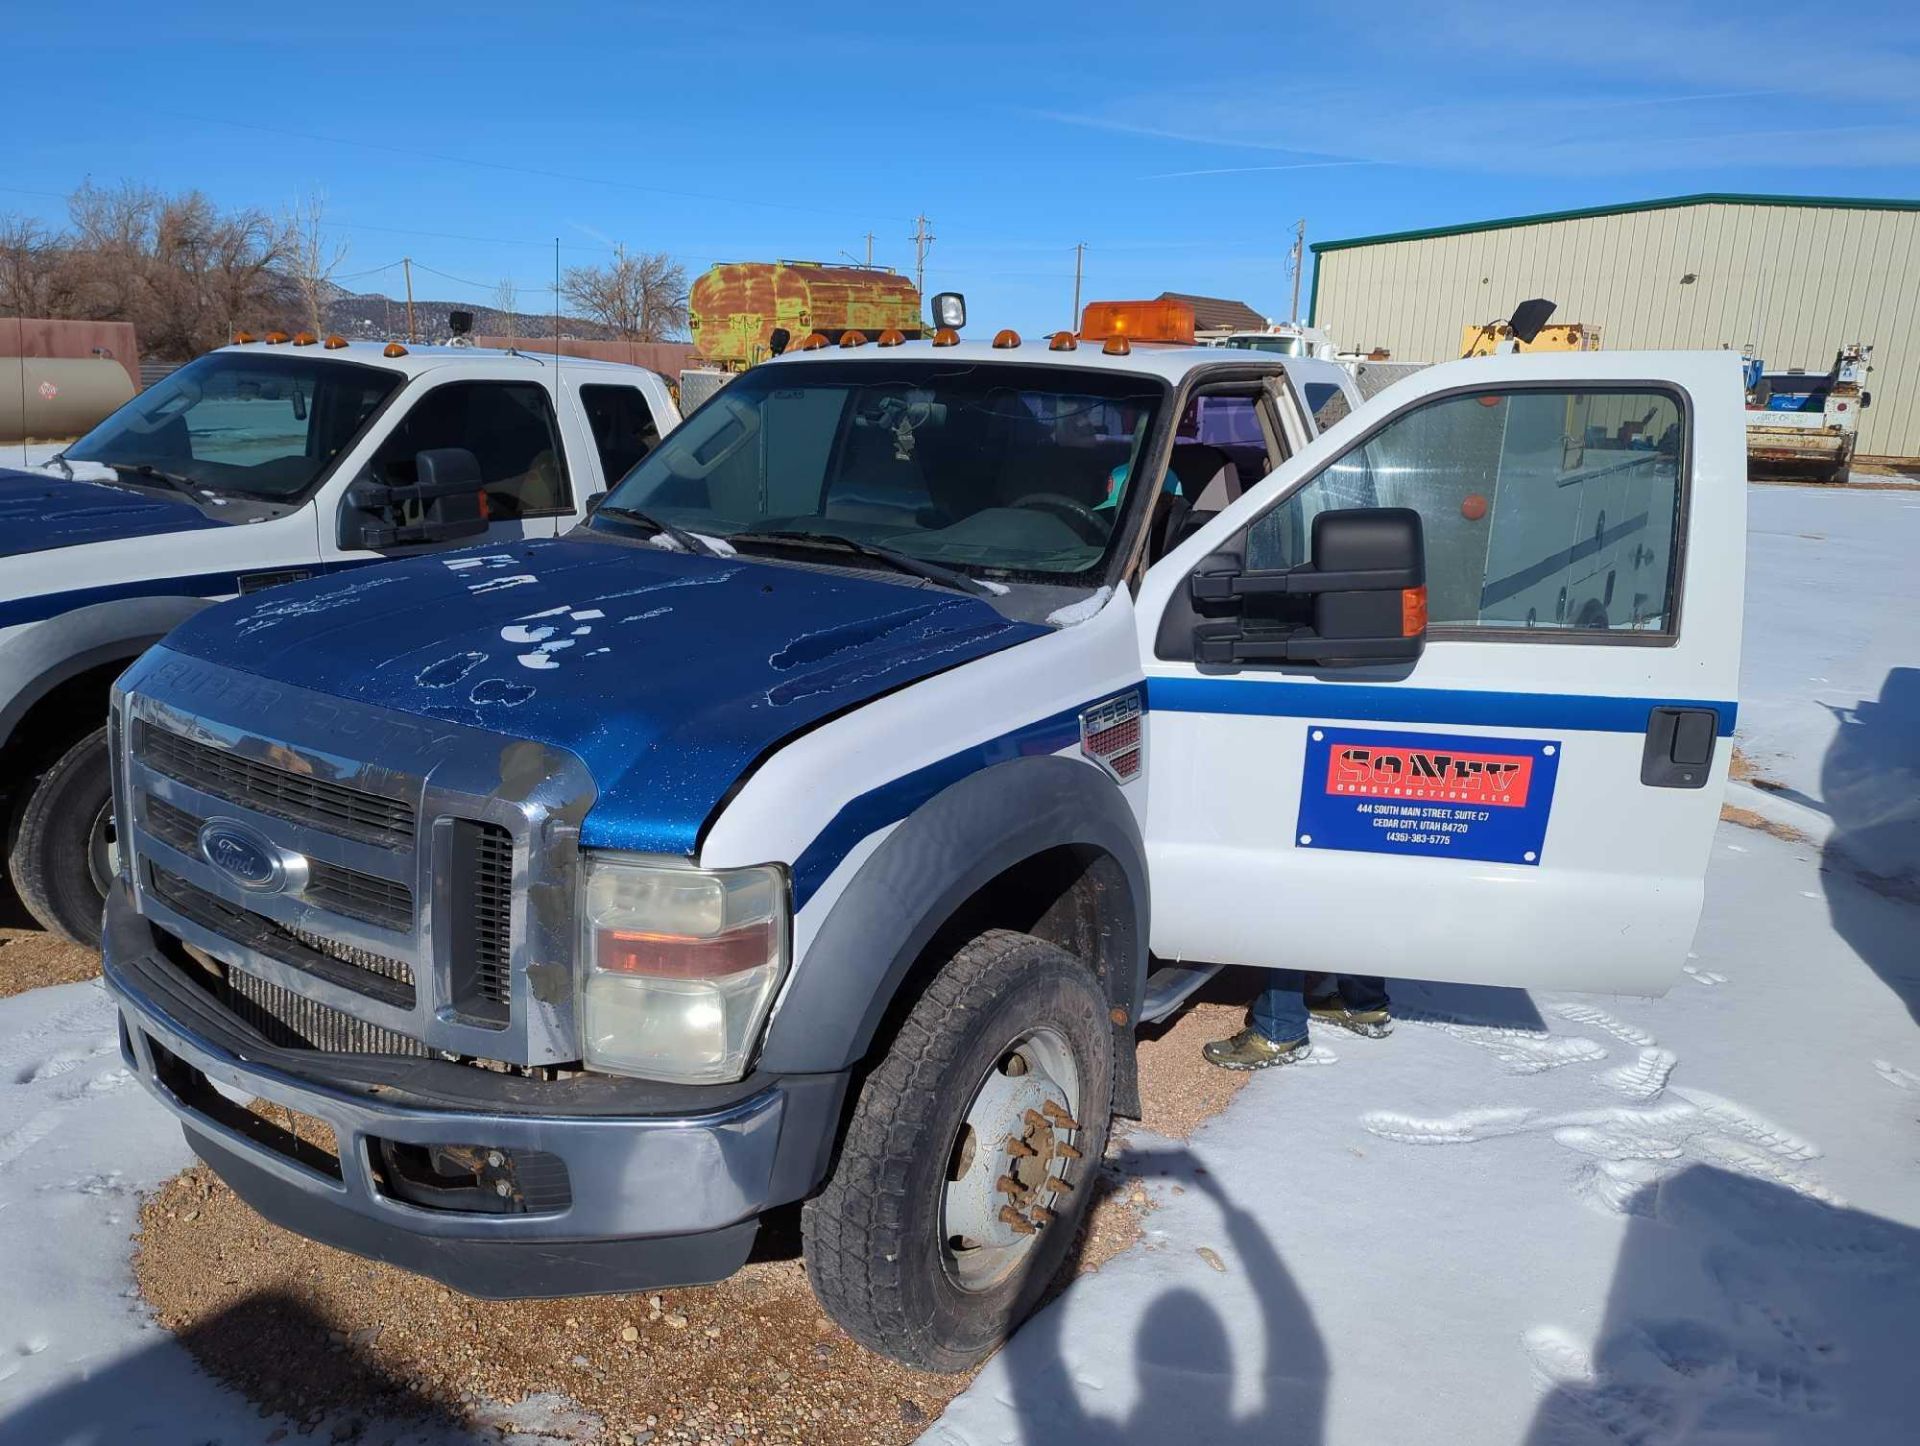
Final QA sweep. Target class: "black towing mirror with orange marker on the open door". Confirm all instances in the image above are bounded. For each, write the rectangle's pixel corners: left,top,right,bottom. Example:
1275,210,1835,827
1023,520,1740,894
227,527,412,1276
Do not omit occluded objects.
1162,507,1427,668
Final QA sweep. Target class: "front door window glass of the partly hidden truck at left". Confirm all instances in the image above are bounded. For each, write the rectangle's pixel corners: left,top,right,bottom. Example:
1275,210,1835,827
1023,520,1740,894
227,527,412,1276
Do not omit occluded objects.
372,382,572,522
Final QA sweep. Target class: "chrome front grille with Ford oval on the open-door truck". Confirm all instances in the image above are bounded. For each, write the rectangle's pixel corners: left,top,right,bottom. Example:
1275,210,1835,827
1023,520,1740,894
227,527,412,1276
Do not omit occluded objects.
115,645,593,1066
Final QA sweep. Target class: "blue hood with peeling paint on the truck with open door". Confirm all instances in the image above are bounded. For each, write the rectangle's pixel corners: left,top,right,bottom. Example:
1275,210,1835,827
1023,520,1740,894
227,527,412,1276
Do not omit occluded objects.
167,538,1046,855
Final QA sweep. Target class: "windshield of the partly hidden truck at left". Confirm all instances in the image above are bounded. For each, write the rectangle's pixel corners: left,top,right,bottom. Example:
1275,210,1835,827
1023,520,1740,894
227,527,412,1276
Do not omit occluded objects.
65,351,405,501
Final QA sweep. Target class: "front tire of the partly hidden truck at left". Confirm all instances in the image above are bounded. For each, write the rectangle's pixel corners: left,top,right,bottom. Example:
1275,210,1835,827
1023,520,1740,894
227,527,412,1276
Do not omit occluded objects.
8,728,113,949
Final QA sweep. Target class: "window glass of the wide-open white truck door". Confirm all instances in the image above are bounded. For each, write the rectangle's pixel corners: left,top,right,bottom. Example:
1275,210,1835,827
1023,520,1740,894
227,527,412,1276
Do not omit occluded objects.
1246,390,1684,634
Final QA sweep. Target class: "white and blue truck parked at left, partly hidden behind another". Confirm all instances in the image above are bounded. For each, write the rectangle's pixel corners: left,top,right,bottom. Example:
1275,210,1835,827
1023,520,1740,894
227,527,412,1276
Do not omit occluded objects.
0,332,680,945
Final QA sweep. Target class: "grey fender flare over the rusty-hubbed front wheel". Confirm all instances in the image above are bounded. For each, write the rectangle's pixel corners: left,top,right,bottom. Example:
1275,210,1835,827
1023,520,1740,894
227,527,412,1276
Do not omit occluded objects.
758,755,1148,1079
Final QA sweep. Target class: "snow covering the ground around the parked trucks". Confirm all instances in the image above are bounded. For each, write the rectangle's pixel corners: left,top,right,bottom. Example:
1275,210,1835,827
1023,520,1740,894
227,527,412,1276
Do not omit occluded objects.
0,488,1920,1446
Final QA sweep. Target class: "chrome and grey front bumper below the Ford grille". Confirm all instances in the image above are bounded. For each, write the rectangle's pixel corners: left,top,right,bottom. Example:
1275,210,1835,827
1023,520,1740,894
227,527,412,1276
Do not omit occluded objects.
104,885,847,1298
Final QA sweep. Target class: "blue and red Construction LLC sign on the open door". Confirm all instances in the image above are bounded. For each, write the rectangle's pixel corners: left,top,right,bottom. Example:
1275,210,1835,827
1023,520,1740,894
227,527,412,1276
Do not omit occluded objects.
1294,724,1561,864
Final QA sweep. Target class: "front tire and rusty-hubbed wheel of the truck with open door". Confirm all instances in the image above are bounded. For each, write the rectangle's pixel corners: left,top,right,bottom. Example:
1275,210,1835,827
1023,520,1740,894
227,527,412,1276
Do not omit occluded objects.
801,929,1114,1371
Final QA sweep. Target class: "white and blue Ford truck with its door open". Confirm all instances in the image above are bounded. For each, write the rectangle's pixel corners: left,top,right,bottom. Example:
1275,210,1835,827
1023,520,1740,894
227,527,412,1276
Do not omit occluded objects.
106,305,1745,1369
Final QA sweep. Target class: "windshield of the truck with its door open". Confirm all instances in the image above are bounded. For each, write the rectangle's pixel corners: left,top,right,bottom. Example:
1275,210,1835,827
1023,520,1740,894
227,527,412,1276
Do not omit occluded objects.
593,361,1165,580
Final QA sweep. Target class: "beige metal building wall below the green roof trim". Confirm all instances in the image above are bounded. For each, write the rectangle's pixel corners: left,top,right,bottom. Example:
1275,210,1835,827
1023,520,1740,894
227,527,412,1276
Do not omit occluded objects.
1311,200,1920,457
